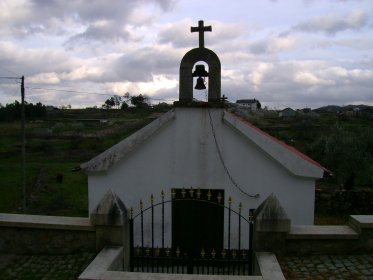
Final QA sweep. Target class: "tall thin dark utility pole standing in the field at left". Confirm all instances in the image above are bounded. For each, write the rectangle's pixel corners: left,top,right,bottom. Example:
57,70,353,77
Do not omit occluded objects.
21,76,27,213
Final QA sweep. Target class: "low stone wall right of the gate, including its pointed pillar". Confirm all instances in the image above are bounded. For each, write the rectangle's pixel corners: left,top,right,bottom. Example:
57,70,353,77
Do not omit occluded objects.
254,195,373,256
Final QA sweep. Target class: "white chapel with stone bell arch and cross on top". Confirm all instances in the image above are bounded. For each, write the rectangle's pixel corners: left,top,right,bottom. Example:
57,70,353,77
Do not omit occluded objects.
81,21,326,249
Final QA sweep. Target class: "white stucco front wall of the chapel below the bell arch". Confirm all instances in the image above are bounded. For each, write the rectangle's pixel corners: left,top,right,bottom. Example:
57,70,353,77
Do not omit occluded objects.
88,108,315,247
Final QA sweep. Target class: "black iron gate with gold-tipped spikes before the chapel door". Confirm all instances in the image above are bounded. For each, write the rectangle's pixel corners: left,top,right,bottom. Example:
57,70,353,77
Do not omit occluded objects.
130,188,254,275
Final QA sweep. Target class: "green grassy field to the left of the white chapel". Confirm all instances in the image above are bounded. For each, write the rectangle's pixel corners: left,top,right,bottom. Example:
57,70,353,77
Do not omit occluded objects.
0,110,152,216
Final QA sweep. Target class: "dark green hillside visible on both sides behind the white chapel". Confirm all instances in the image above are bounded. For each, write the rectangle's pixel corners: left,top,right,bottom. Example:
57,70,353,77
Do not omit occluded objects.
0,106,373,223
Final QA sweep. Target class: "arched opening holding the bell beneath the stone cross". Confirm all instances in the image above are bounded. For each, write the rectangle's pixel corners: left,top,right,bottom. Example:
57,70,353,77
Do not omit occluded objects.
192,61,209,102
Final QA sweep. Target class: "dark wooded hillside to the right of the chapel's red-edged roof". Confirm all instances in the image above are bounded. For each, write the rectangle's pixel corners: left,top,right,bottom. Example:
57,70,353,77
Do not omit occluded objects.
234,105,373,189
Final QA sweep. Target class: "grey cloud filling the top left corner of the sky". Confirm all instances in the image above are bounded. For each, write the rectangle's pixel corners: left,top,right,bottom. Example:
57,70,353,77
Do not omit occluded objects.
0,0,176,39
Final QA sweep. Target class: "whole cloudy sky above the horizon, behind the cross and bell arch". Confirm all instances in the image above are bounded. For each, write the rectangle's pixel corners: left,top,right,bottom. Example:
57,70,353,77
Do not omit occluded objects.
0,0,373,109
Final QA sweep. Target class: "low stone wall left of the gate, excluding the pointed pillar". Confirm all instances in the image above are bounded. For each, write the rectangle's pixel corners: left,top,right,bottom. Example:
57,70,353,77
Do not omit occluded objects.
0,214,96,254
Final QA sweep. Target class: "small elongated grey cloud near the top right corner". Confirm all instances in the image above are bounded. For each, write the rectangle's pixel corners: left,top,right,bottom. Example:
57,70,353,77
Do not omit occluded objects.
292,11,368,35
